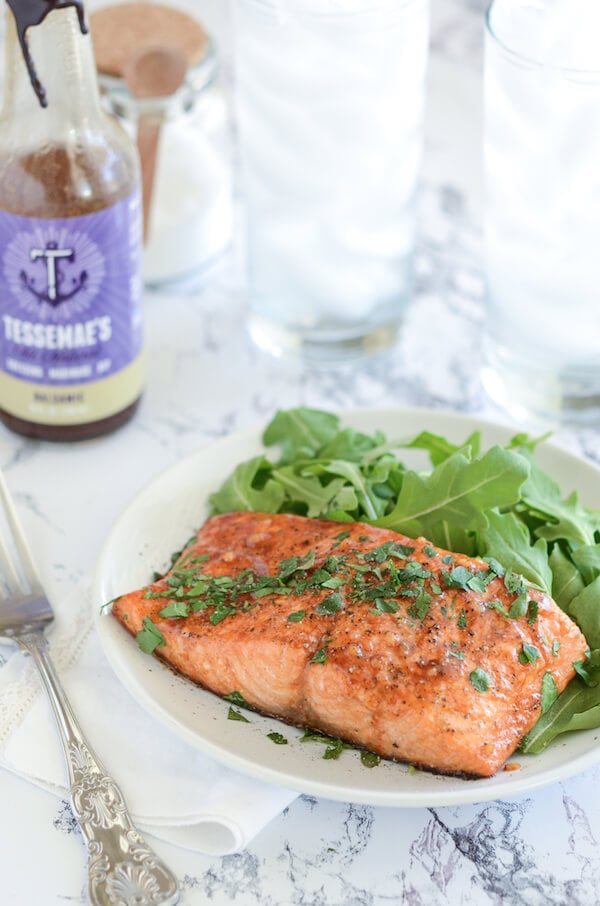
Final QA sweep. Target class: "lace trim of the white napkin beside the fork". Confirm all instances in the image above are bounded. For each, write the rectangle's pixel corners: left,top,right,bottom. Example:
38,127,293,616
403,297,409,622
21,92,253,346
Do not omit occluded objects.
0,593,92,751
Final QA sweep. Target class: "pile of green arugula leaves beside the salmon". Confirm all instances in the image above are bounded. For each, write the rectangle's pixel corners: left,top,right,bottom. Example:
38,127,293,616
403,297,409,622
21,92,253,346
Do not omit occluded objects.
209,407,600,753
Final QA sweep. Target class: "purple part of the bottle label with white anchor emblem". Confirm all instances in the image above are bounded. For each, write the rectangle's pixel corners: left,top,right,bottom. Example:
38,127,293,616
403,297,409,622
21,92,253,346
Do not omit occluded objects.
0,193,142,387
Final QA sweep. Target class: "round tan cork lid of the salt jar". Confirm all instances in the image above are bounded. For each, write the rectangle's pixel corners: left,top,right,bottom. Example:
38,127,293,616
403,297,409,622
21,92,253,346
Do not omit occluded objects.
89,2,209,76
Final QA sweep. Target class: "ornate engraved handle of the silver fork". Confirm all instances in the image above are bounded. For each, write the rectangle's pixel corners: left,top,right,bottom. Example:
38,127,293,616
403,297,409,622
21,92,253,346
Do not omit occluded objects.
15,629,179,906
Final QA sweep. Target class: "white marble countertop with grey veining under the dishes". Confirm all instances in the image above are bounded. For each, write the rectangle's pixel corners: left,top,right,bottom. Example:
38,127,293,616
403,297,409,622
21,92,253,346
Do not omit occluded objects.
0,0,600,906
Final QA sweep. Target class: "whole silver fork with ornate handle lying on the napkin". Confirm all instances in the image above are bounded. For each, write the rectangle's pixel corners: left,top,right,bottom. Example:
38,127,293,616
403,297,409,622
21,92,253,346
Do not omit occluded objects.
0,473,179,906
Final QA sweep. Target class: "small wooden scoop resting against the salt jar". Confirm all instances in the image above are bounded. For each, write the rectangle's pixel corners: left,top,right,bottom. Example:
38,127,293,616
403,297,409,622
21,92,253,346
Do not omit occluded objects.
123,47,187,240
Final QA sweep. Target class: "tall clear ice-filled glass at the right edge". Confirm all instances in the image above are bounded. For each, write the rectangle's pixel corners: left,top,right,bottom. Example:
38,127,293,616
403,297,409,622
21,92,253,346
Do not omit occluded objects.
482,0,600,424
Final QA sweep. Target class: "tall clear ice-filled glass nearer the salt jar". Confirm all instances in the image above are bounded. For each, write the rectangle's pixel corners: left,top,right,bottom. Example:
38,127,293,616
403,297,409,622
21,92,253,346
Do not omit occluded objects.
233,0,429,361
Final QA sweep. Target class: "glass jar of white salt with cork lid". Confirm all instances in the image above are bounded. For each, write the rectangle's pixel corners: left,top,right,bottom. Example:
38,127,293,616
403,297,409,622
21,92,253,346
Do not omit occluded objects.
90,3,233,289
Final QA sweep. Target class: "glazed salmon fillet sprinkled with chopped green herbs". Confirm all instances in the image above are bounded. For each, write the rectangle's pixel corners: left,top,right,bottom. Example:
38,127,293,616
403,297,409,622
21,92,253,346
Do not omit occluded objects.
112,512,587,777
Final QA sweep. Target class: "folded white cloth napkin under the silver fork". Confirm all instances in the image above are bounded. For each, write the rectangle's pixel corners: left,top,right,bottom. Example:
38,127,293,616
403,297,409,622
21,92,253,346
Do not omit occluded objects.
0,590,297,855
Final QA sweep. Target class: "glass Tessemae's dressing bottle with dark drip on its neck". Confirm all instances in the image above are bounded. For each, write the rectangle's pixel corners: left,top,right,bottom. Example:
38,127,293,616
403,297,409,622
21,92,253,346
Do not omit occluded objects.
0,0,143,440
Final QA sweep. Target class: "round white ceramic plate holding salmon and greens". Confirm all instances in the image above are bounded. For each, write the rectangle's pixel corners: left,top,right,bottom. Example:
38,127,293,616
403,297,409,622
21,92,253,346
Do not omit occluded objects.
95,409,600,807
